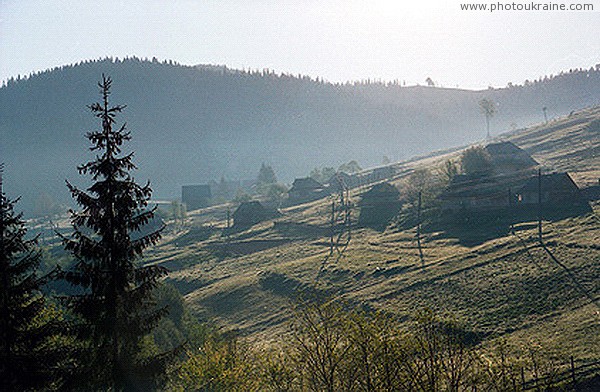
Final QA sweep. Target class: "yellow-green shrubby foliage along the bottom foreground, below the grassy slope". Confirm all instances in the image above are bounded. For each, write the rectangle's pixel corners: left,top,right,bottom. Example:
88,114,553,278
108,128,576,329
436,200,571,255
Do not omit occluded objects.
163,300,576,392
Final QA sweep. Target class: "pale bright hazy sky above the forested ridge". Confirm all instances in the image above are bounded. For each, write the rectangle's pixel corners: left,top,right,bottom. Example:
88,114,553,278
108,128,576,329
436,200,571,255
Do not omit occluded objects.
0,0,600,88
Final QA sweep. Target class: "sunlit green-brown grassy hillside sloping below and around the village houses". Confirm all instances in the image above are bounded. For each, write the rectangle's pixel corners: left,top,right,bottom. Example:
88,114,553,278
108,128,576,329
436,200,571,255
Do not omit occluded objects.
143,108,600,362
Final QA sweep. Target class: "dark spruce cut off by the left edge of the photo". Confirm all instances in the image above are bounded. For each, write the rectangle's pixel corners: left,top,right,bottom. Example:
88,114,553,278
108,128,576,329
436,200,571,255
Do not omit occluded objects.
0,165,65,391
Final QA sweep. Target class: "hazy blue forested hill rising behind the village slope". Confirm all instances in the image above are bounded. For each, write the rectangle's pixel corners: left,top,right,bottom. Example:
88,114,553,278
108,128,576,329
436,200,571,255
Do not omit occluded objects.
0,59,600,213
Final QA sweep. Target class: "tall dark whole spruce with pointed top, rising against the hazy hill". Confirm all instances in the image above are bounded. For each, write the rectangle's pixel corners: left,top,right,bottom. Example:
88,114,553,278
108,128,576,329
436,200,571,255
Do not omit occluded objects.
64,75,167,391
